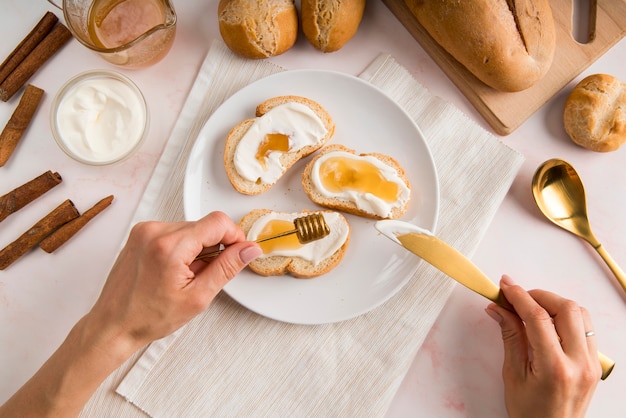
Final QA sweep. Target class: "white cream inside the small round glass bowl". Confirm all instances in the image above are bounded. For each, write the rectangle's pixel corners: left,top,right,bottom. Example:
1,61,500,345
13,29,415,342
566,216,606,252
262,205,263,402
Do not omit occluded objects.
56,76,147,163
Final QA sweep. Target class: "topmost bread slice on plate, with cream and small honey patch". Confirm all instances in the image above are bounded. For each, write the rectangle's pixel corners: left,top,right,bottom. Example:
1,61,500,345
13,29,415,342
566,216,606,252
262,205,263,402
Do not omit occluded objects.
224,96,335,195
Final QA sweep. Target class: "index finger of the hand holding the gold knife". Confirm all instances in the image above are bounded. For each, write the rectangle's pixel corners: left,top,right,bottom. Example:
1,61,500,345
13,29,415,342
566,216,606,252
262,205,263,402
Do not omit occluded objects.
500,276,562,355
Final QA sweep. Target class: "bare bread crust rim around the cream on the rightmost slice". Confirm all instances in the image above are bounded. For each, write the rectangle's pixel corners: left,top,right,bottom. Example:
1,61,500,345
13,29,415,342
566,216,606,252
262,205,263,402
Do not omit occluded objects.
302,144,411,219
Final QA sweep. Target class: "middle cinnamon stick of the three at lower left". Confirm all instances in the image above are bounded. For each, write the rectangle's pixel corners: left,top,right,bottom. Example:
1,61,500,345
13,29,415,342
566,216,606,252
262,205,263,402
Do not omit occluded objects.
0,199,79,270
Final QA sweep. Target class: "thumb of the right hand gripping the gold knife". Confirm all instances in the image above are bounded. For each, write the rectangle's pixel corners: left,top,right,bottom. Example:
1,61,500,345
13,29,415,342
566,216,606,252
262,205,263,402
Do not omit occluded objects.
485,303,529,373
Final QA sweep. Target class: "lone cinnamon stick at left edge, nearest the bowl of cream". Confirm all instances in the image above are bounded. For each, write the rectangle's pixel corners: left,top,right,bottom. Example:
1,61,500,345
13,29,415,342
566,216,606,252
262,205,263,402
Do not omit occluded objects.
0,84,43,167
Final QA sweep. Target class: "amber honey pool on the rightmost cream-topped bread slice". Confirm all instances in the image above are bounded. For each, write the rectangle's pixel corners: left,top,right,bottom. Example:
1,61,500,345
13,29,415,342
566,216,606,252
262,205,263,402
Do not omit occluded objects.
319,157,399,202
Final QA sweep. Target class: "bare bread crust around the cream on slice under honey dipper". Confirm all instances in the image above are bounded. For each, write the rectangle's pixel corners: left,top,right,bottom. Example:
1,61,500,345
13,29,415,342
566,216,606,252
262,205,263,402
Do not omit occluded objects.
239,209,350,279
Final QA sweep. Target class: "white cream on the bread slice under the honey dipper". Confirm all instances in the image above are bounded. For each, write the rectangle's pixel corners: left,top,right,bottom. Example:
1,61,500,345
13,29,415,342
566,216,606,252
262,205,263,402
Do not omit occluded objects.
247,212,350,265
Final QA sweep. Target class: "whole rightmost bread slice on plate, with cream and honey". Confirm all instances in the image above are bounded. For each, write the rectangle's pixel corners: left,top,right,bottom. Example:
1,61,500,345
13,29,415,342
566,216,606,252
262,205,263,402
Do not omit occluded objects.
302,144,411,219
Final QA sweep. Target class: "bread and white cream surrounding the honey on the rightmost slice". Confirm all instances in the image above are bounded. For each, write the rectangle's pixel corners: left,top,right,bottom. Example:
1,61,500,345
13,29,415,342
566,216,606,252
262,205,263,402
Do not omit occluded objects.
302,144,411,219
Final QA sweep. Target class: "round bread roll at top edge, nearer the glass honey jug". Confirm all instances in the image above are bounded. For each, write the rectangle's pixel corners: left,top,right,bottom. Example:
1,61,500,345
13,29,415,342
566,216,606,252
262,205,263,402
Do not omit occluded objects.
217,0,298,59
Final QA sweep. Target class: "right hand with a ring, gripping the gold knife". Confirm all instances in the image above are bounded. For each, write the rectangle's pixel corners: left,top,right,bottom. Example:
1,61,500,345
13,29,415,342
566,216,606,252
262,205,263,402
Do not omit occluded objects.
486,276,602,418
